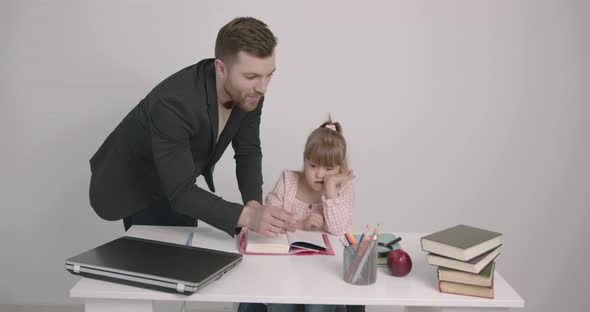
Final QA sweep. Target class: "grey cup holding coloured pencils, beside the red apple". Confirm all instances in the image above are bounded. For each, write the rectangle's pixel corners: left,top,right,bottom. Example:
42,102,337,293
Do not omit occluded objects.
342,242,377,285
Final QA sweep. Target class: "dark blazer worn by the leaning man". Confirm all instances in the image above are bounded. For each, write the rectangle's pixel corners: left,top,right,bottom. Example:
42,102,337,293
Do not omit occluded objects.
90,59,264,235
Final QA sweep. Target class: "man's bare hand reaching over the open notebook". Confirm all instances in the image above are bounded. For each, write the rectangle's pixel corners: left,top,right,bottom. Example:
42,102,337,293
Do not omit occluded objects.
238,201,295,237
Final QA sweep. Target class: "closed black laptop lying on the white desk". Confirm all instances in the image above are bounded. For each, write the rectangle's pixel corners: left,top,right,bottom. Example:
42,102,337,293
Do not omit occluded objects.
66,236,242,295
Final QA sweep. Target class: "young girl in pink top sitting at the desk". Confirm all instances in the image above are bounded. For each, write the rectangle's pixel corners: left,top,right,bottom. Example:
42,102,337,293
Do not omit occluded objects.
266,120,354,312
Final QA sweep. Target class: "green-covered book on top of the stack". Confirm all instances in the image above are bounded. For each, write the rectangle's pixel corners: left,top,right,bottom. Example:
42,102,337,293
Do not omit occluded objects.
420,225,502,261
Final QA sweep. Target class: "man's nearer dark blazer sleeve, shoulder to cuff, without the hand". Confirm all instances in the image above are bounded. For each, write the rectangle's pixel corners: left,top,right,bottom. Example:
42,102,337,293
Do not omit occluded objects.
149,98,244,236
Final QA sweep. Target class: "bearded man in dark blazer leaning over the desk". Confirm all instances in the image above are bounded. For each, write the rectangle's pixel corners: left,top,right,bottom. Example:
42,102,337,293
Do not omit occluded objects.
90,17,295,237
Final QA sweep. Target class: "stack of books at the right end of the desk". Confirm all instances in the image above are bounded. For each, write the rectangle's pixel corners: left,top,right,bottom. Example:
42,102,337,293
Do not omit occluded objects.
420,225,502,298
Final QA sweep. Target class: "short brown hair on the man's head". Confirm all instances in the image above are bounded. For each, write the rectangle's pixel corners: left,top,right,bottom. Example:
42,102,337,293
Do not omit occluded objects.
215,17,277,62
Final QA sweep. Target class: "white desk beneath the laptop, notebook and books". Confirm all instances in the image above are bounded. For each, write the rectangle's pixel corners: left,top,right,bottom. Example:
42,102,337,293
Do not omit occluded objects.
70,227,524,312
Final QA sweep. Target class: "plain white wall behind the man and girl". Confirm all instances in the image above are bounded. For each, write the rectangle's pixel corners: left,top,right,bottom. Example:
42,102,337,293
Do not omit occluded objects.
0,0,590,311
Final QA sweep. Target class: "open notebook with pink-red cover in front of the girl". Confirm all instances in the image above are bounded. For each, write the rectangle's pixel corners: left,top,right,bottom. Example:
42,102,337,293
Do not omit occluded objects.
240,230,334,255
